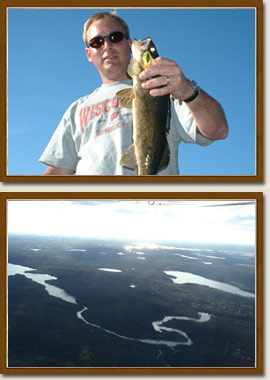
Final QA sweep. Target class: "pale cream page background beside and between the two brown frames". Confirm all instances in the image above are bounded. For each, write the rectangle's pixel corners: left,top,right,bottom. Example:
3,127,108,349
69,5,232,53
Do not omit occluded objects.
0,0,270,380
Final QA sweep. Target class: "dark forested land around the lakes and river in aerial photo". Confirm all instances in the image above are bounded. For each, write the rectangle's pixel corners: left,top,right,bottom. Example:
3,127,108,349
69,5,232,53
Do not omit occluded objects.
8,236,256,367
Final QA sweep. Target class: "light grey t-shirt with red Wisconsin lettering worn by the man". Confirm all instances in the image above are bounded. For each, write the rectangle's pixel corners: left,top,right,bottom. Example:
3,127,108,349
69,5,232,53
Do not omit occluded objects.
39,80,212,175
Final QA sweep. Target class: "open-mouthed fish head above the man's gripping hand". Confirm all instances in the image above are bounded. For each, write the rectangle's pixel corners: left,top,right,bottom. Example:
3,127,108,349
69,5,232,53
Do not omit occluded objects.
131,37,158,67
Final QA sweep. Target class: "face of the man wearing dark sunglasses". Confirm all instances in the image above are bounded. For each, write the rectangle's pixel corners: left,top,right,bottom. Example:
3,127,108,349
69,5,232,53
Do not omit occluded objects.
85,19,131,83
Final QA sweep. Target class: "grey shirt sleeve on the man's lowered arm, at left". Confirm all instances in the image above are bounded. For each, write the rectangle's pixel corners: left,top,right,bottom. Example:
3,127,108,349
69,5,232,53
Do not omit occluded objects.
39,109,79,171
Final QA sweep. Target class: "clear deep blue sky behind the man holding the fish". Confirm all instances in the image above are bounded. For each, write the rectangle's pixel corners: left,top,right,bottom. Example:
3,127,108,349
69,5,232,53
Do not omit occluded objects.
8,8,256,175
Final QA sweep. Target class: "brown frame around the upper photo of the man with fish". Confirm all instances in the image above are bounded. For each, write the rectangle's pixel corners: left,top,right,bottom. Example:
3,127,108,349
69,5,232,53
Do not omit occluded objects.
0,0,263,183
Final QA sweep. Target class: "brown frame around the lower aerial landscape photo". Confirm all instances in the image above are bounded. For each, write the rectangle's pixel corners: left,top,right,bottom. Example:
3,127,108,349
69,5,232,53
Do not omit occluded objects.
0,192,263,375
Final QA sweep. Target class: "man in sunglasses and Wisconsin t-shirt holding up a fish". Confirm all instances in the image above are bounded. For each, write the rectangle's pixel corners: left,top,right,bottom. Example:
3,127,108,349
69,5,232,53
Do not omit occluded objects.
40,12,228,175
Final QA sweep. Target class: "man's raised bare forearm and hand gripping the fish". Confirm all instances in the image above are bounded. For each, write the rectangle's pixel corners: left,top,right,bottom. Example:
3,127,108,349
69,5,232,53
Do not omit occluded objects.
140,57,228,140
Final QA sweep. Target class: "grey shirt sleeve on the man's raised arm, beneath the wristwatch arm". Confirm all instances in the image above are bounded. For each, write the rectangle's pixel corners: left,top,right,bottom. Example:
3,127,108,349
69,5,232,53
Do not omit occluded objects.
171,99,213,146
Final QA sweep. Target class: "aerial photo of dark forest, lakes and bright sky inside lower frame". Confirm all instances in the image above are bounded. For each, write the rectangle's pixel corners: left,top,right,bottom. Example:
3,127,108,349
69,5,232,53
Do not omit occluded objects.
7,200,256,368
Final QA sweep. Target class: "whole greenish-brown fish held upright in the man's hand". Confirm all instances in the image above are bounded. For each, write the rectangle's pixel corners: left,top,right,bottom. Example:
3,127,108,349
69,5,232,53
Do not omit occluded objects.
116,37,170,175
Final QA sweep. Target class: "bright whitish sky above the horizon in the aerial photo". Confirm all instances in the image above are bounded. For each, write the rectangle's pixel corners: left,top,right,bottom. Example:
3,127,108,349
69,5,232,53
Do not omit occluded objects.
8,200,256,246
